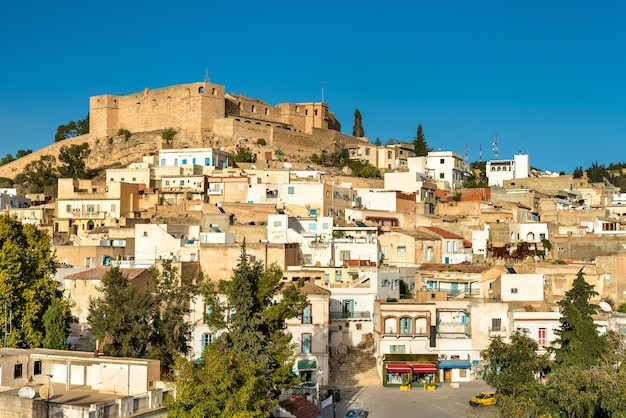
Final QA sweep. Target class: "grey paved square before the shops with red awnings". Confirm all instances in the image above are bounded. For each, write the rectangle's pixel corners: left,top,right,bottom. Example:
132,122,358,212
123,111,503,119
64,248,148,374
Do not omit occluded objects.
336,381,498,418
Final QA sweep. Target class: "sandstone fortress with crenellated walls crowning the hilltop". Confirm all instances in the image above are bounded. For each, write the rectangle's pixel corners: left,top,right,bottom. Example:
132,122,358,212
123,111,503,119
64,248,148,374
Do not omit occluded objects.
89,82,354,146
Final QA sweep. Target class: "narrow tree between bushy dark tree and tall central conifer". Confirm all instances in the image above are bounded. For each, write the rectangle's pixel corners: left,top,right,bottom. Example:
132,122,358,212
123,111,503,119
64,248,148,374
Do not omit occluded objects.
147,260,199,376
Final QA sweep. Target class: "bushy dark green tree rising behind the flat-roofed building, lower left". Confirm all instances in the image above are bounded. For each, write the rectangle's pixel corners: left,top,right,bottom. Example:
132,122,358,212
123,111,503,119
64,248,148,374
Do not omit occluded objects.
87,267,151,357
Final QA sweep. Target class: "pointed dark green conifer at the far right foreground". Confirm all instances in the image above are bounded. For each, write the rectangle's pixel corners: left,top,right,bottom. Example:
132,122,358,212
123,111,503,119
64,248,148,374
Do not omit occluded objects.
554,269,608,369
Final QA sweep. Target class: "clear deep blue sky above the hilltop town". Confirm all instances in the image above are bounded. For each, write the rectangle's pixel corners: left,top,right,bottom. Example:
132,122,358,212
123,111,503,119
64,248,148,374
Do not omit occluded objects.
0,0,626,173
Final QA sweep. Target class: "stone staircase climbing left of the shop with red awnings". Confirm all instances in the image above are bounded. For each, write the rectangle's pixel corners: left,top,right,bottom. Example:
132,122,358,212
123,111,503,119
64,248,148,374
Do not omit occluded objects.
328,334,380,388
